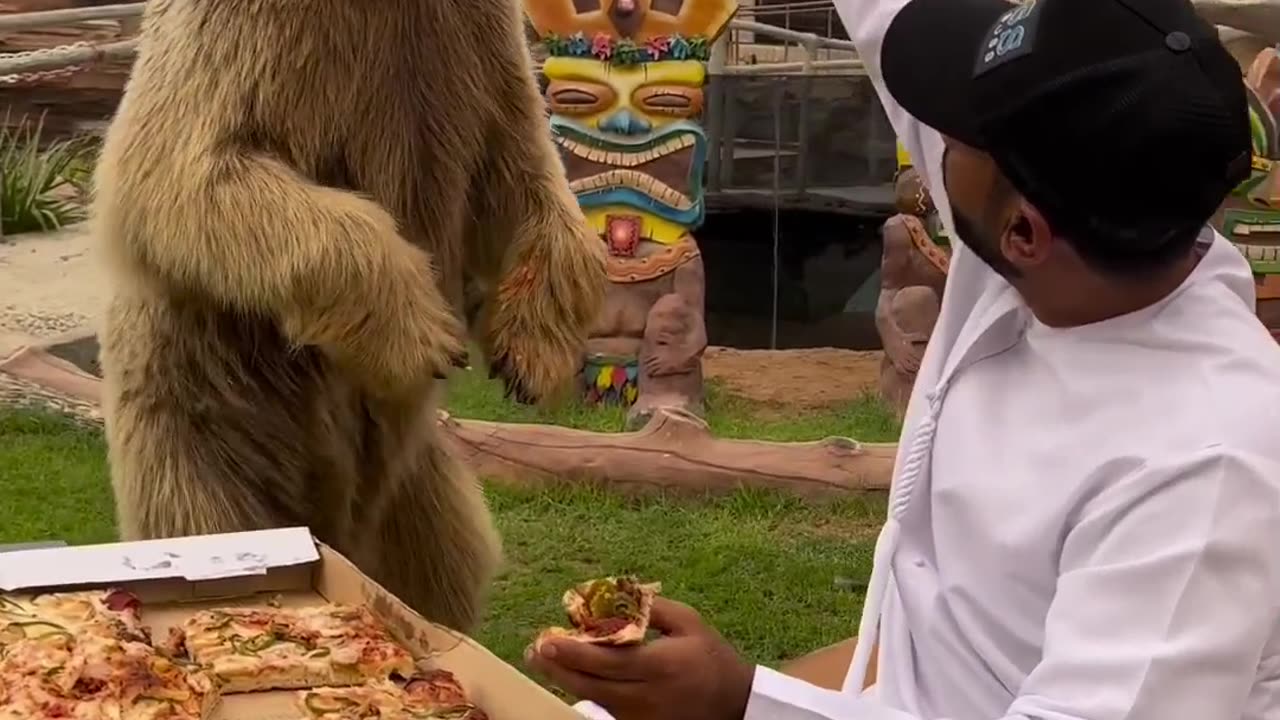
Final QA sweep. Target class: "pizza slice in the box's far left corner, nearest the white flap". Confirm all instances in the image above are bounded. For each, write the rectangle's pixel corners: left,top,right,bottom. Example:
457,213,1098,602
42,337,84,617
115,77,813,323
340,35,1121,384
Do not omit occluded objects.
0,588,151,647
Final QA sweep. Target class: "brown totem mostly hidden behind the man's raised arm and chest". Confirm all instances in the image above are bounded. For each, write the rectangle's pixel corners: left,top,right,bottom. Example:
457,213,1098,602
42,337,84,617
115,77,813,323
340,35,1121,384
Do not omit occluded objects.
876,145,951,415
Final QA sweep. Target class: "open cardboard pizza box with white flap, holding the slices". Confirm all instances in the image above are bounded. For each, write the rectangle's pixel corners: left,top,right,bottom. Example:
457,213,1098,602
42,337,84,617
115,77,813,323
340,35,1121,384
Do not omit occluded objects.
0,528,581,720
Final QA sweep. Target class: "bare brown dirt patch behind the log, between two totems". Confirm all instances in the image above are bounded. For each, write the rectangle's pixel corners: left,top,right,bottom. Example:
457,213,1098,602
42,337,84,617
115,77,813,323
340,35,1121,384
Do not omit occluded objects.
703,347,882,410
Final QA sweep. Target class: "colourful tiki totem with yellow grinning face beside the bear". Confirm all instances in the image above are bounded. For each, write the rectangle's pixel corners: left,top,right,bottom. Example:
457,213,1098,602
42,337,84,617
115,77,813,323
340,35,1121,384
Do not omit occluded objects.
524,0,737,428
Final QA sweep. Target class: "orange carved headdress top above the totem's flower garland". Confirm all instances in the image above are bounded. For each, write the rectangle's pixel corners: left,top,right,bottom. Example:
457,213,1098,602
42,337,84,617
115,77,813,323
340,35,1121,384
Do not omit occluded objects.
525,0,737,41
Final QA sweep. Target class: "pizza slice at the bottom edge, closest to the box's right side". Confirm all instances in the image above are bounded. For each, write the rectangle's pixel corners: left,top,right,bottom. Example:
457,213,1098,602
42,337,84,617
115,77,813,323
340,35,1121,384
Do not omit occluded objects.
297,670,489,720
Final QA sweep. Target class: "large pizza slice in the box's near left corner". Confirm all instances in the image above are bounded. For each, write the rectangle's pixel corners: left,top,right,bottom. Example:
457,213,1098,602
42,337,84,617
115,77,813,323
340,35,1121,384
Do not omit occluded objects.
0,634,219,720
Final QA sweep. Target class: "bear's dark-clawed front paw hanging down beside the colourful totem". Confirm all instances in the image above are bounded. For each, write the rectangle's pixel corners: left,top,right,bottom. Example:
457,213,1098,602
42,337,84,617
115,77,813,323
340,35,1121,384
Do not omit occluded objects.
488,256,607,404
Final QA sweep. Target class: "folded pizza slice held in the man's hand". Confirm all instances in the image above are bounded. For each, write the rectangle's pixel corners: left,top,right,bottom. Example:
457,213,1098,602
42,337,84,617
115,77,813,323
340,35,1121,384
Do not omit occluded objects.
534,575,662,647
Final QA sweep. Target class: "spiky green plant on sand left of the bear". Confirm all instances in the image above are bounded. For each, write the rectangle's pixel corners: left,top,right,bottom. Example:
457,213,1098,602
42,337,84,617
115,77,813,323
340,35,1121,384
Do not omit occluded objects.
0,112,93,234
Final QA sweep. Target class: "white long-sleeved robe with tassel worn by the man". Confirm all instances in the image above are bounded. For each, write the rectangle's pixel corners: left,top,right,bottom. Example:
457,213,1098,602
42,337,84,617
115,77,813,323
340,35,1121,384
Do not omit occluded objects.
580,0,1280,720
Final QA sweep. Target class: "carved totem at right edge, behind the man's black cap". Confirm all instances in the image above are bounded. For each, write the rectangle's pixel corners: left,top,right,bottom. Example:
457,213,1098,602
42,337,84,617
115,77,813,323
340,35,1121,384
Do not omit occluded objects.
1213,47,1280,340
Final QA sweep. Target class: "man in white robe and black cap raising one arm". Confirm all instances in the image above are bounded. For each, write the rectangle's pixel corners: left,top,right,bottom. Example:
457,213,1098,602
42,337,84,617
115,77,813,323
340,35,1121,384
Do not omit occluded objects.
529,0,1280,720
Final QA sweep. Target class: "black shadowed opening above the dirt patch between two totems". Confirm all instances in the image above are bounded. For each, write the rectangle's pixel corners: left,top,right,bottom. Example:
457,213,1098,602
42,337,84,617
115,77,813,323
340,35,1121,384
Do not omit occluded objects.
695,210,881,350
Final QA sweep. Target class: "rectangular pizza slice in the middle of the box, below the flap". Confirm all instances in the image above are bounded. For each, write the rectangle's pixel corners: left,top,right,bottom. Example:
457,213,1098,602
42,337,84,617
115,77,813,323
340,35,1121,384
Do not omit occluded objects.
170,605,413,693
